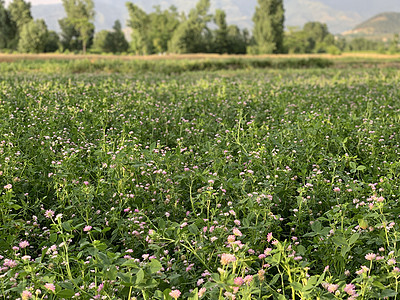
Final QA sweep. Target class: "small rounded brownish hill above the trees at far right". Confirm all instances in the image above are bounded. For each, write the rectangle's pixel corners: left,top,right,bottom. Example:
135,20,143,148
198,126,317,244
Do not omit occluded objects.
343,12,400,37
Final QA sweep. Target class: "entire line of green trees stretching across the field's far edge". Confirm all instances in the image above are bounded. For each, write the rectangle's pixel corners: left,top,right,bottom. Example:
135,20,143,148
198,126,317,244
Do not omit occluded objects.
0,0,397,55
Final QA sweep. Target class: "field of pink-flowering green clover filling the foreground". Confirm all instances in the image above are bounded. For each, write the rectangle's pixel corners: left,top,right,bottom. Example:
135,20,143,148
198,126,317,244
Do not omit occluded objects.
0,69,400,300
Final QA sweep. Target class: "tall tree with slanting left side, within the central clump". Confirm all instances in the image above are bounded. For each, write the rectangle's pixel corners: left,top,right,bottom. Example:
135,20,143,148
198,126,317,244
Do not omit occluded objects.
168,0,212,53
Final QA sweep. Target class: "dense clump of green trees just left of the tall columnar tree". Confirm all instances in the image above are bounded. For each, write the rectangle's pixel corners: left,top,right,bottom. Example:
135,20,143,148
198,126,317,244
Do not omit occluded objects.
126,0,250,54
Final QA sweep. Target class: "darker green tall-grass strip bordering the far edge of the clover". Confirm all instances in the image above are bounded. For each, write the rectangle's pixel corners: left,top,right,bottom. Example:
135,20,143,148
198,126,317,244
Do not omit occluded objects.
0,58,333,74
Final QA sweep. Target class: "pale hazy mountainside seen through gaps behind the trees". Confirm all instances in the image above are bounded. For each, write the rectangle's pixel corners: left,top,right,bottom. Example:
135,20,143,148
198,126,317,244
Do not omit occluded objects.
29,0,400,34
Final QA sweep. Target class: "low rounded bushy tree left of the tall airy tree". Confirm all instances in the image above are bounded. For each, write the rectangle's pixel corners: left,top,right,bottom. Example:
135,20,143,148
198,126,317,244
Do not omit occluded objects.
18,20,48,53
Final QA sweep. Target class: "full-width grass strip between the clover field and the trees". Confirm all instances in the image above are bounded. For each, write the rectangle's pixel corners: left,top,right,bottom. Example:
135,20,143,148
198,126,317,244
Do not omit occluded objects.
0,53,400,74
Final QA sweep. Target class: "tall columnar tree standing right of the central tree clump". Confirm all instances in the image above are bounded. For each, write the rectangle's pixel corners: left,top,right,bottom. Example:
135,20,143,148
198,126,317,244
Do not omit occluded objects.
250,0,285,54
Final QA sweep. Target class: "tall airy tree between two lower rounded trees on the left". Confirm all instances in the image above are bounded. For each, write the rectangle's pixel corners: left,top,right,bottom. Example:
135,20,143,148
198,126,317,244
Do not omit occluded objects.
59,0,95,53
